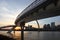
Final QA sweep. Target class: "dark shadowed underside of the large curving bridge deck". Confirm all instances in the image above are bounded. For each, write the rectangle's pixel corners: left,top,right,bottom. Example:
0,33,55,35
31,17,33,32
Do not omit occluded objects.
15,1,60,24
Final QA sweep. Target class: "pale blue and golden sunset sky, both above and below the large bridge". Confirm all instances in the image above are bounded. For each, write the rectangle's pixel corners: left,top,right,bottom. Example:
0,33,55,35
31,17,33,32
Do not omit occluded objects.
0,0,60,26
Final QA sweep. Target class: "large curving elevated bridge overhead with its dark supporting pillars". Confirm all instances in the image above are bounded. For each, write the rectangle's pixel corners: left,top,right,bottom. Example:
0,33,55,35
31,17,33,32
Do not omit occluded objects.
0,0,60,40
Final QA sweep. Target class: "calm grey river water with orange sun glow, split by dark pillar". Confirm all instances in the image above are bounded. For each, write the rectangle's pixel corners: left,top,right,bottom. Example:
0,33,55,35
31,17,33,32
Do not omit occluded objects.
0,31,60,40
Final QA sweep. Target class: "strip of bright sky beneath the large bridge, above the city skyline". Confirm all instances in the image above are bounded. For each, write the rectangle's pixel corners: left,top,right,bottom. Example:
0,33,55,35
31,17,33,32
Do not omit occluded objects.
26,16,60,28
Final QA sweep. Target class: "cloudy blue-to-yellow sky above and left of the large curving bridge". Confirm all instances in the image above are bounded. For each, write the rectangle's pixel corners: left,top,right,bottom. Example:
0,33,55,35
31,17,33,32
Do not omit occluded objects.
0,0,34,26
